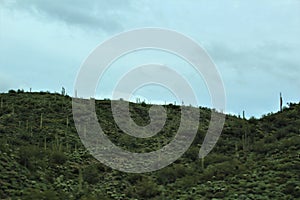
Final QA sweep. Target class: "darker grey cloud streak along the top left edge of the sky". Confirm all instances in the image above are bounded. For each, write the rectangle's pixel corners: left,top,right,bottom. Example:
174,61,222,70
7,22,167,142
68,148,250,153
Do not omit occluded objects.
0,0,133,32
